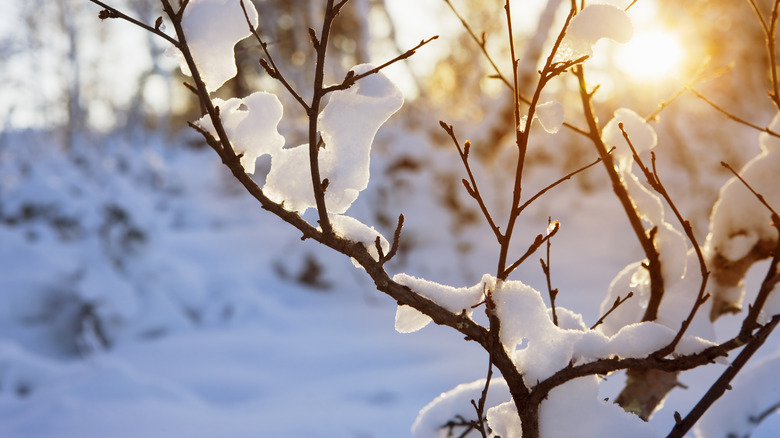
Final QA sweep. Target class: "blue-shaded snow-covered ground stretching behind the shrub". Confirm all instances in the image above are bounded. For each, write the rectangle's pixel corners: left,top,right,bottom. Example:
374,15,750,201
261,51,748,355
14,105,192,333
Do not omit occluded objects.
0,120,780,438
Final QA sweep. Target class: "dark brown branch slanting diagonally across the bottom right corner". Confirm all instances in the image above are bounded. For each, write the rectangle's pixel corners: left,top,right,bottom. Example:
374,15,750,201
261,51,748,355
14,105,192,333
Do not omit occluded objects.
667,316,780,438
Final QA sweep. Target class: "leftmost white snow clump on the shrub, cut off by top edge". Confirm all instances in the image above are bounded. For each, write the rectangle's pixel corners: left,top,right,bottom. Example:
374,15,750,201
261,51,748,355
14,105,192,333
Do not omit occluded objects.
179,0,257,92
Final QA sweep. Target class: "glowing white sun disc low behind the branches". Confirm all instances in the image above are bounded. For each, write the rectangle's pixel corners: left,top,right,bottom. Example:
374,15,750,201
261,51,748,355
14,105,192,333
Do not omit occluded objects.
614,30,684,81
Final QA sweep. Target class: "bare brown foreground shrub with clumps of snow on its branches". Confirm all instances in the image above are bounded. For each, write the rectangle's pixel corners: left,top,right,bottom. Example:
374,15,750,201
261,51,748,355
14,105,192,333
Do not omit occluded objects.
85,0,780,438
